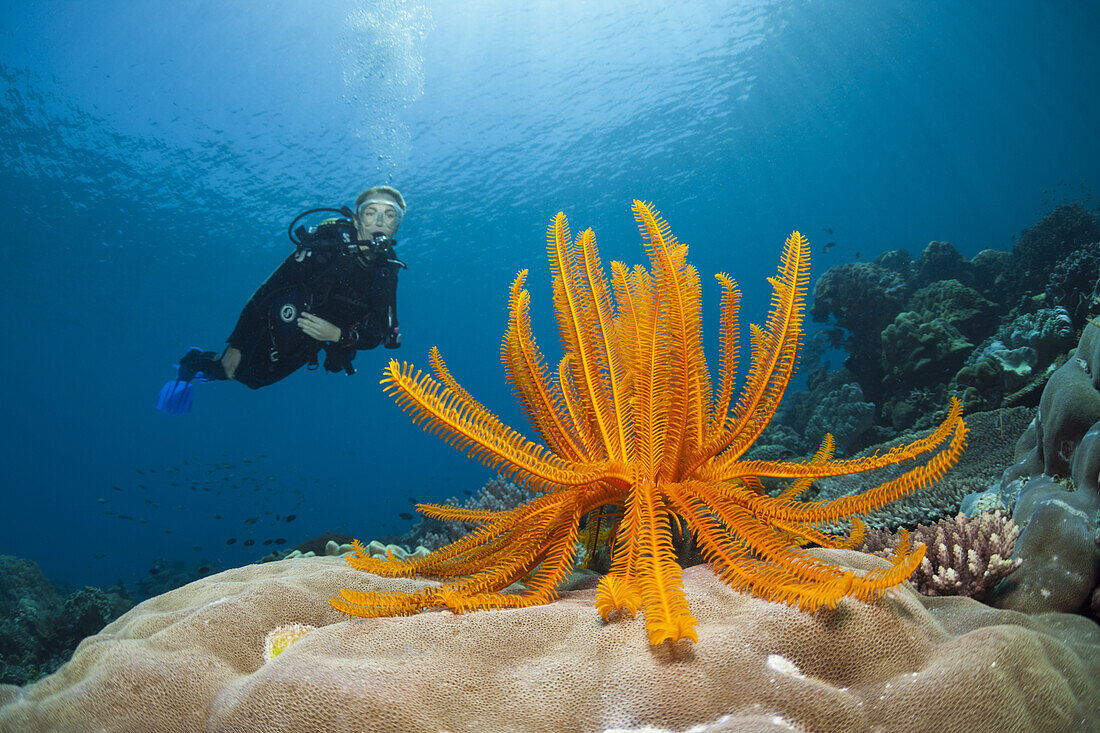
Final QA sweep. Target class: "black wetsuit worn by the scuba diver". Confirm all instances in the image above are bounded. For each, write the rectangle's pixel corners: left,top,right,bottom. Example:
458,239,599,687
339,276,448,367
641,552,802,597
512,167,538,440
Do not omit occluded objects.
227,240,399,390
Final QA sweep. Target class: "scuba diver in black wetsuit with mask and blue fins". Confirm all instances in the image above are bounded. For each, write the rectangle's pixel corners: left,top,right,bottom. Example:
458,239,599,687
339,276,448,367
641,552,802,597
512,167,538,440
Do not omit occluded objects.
156,186,405,415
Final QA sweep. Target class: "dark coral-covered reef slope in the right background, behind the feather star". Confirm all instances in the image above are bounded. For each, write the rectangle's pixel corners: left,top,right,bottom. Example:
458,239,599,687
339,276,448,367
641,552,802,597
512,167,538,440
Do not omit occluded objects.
800,205,1100,450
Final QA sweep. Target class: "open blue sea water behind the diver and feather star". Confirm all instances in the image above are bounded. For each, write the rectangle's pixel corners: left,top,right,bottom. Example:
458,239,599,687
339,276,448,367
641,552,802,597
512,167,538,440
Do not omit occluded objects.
0,0,1100,584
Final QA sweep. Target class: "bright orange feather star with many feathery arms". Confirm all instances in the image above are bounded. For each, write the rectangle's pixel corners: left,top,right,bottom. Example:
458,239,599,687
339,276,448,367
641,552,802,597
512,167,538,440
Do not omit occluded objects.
332,200,966,644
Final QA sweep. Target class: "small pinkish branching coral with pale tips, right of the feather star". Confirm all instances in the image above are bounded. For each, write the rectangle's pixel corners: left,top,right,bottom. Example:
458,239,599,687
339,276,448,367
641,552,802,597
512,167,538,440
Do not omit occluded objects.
862,511,1023,601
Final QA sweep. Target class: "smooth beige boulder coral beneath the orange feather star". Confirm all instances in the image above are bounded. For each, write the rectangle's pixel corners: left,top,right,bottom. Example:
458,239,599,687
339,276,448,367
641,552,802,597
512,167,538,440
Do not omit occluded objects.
0,550,1100,733
